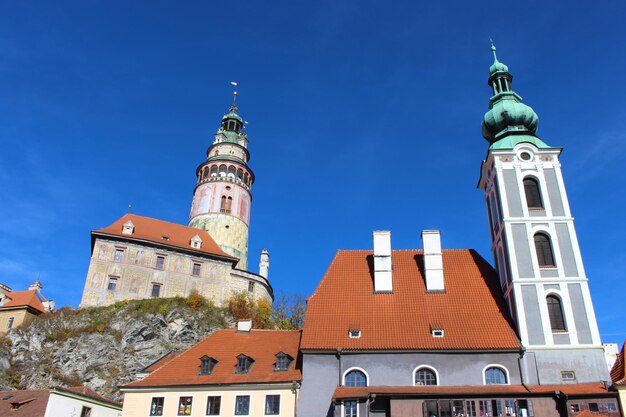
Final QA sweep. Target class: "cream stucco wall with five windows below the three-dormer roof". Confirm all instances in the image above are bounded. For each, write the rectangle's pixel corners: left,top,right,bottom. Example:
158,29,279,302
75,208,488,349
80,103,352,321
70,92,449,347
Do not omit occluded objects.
122,384,296,417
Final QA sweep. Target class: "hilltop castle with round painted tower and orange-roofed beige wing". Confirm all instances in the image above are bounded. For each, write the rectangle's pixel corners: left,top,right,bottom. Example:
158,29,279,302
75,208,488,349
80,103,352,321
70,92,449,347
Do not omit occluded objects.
80,99,274,307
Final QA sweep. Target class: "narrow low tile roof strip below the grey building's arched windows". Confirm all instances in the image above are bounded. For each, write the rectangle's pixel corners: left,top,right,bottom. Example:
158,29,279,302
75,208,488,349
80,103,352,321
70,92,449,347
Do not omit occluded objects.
333,384,608,398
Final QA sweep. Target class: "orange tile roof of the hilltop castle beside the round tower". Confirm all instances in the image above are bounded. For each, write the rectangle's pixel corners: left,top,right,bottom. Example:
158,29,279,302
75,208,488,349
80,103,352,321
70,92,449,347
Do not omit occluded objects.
92,213,236,259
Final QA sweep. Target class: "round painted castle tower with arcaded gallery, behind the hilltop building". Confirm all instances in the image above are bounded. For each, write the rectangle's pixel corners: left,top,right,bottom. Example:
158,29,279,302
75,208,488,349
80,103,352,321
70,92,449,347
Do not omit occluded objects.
189,103,254,270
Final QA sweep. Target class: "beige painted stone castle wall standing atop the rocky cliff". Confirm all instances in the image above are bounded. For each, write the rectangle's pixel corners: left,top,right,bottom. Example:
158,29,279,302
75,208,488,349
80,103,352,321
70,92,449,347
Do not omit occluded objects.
80,239,273,307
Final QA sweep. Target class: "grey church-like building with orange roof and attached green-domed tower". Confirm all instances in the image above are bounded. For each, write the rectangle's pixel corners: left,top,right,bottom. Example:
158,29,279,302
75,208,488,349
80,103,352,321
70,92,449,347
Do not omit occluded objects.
298,48,621,417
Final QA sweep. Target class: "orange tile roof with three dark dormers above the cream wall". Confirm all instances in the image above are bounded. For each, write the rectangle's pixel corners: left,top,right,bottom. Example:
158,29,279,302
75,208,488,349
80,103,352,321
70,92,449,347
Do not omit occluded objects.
122,329,302,389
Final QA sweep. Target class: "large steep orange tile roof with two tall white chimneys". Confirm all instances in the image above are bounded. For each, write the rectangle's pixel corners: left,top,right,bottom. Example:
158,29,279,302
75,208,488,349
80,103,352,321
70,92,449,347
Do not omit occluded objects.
301,250,521,350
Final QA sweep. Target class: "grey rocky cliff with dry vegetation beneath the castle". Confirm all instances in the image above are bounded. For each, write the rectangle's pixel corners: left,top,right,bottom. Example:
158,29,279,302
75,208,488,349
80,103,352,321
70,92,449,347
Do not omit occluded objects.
0,295,234,400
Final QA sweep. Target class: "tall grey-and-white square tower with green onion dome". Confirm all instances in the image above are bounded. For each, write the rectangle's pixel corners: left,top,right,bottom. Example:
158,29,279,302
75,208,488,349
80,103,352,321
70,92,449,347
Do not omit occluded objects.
478,47,609,384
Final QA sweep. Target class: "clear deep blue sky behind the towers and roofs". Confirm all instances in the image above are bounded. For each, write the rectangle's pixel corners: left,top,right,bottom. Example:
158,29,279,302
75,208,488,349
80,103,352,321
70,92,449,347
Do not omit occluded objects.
0,0,626,343
